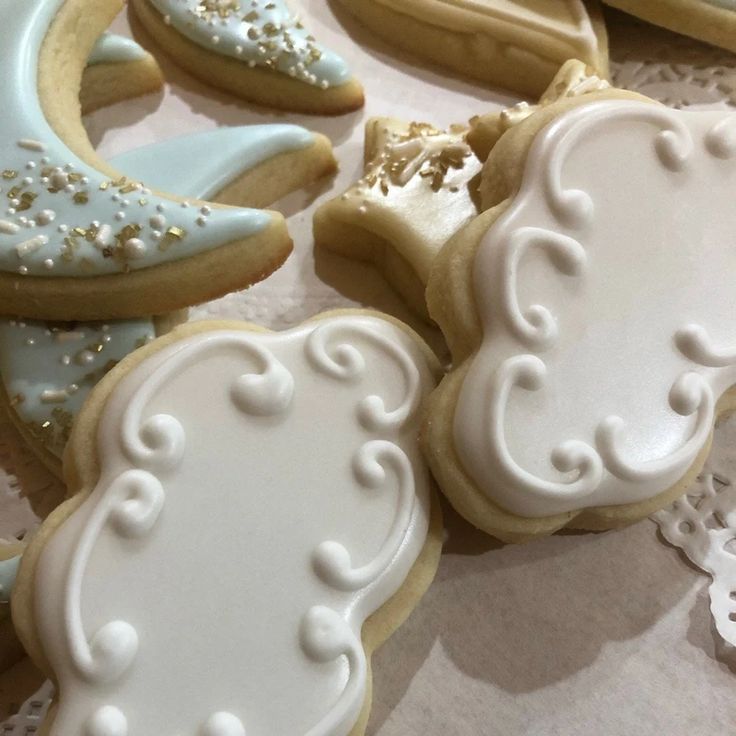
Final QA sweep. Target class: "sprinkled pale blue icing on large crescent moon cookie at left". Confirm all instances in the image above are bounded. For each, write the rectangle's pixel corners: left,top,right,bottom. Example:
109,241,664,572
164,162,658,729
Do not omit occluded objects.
0,0,270,277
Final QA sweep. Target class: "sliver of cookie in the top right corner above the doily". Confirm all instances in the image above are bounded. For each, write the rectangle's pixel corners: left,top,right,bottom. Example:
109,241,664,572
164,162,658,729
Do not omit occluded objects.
603,0,736,52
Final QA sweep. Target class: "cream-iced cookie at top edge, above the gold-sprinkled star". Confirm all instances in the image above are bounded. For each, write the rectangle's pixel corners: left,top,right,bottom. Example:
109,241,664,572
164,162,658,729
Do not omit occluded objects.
341,0,608,96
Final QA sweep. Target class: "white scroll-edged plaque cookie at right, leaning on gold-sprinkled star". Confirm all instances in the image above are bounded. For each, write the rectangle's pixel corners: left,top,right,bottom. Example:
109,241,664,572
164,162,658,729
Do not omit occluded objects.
423,92,736,541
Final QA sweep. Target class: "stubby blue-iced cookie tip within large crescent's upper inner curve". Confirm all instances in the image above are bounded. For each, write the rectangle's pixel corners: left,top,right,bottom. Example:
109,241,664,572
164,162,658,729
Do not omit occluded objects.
79,33,164,115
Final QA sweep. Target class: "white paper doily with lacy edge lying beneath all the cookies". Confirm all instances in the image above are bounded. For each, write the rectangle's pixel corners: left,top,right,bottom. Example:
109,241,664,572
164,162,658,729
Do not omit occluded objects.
0,0,736,736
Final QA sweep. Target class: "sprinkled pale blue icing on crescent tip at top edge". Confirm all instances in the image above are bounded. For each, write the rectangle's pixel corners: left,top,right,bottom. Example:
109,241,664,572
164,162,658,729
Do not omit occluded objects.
149,0,352,89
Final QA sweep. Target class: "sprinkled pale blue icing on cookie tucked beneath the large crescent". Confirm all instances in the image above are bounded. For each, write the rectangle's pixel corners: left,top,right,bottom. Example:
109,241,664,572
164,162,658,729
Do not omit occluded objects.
0,319,155,457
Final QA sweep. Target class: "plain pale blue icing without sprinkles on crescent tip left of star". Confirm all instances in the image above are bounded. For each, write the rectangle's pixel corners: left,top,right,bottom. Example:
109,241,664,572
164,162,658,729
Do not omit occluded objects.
111,125,314,199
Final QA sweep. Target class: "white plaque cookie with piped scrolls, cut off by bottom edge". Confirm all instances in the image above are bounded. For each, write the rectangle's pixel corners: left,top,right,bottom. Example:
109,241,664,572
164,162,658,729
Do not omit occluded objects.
12,312,441,736
